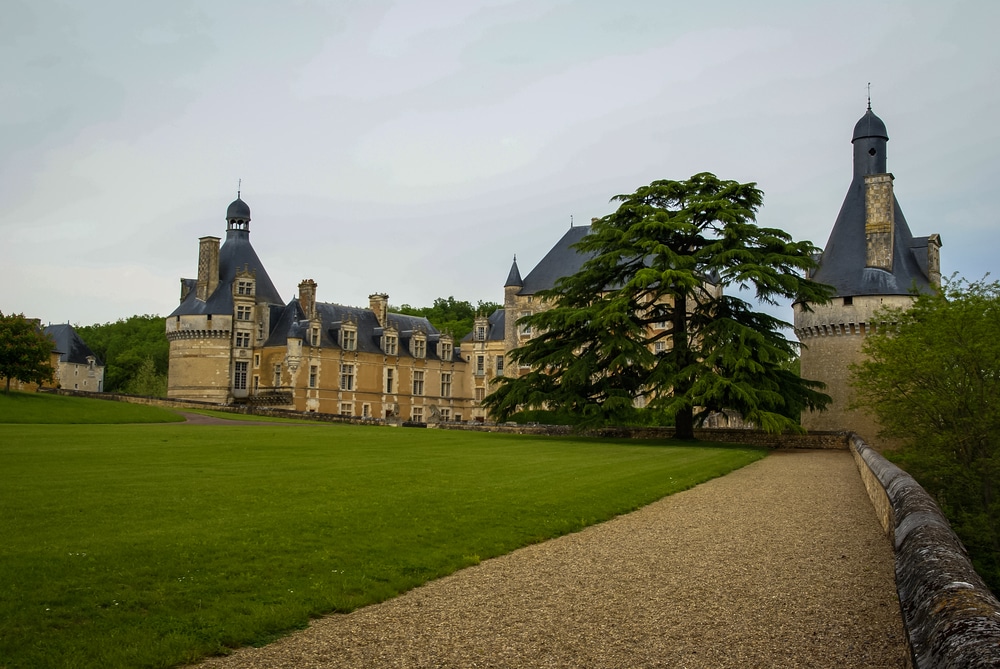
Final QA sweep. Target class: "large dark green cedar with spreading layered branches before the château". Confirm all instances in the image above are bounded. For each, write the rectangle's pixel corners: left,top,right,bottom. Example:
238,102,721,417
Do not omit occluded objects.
485,173,829,439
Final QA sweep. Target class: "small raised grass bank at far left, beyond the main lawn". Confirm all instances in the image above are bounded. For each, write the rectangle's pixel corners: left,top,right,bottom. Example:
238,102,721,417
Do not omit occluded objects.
0,392,184,424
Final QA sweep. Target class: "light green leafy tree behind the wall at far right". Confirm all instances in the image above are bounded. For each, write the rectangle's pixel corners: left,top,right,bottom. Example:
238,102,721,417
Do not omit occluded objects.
852,277,1000,592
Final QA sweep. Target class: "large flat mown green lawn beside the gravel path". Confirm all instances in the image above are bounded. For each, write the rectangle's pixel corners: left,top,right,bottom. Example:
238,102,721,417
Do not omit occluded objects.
0,414,764,668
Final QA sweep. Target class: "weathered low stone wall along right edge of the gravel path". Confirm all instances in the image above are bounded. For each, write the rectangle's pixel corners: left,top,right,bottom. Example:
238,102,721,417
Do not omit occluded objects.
850,435,1000,669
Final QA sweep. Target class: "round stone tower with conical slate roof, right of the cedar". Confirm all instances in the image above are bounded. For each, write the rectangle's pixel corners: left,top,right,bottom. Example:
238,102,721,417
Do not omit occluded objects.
793,105,941,444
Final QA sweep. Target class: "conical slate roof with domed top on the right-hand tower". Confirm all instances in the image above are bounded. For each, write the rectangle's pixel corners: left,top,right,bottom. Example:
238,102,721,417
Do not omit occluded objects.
811,109,931,297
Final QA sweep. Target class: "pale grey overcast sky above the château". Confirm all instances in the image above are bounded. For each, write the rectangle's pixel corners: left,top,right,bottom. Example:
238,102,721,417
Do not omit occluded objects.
0,0,1000,325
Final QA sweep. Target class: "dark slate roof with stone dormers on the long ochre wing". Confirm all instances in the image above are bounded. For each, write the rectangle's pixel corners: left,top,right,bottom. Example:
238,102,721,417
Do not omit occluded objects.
264,298,462,362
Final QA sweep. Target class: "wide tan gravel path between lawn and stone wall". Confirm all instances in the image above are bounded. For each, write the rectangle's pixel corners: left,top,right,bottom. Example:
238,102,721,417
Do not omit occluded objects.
195,451,906,669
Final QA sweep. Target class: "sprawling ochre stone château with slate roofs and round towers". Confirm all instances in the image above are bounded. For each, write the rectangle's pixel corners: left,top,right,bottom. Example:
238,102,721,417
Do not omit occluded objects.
166,106,941,430
